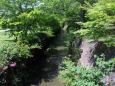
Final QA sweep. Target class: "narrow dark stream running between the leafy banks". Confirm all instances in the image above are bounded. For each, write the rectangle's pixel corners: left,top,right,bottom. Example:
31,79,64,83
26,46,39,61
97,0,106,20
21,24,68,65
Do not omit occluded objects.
31,28,67,86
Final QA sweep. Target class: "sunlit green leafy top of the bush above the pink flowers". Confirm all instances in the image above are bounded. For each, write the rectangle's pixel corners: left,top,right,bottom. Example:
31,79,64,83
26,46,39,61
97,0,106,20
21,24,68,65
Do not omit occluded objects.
0,43,31,67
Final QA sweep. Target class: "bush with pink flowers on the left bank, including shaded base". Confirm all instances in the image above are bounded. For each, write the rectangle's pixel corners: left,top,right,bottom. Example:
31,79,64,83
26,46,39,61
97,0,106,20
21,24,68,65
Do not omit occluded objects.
0,41,32,86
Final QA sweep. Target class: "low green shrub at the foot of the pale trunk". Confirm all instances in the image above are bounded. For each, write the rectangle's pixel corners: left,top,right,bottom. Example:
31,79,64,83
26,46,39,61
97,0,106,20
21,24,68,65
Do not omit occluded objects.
59,55,115,86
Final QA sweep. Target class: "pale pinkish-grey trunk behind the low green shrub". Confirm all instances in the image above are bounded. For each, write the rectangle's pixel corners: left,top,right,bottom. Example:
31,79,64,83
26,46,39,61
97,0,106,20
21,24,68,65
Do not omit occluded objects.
78,39,98,69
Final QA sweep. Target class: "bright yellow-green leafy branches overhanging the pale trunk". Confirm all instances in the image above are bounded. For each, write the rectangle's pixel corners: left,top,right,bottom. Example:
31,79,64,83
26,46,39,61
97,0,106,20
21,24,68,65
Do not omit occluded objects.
75,0,115,46
